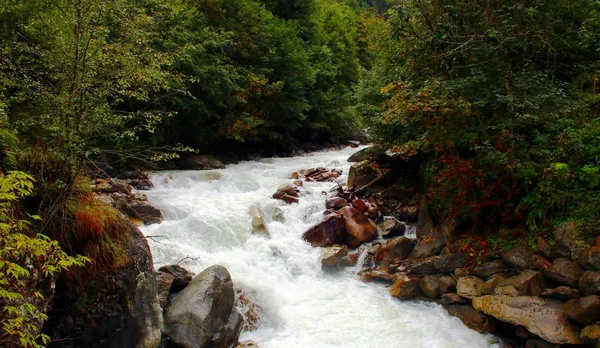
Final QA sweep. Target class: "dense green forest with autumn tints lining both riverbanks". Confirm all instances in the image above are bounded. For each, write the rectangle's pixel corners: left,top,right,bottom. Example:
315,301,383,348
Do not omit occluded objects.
0,0,600,347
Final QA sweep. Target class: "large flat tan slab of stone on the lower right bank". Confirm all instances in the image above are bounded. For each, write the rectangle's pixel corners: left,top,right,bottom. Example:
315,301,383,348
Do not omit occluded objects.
473,295,582,344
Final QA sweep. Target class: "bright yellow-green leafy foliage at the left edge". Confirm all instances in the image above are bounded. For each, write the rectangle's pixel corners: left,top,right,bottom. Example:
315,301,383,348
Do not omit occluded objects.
0,171,88,347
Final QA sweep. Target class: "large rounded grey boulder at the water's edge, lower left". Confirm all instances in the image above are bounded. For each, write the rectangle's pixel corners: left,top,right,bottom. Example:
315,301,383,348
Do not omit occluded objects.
164,266,243,348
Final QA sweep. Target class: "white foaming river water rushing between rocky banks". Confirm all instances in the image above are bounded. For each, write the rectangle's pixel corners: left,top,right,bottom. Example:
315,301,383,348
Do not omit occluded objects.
143,148,494,348
